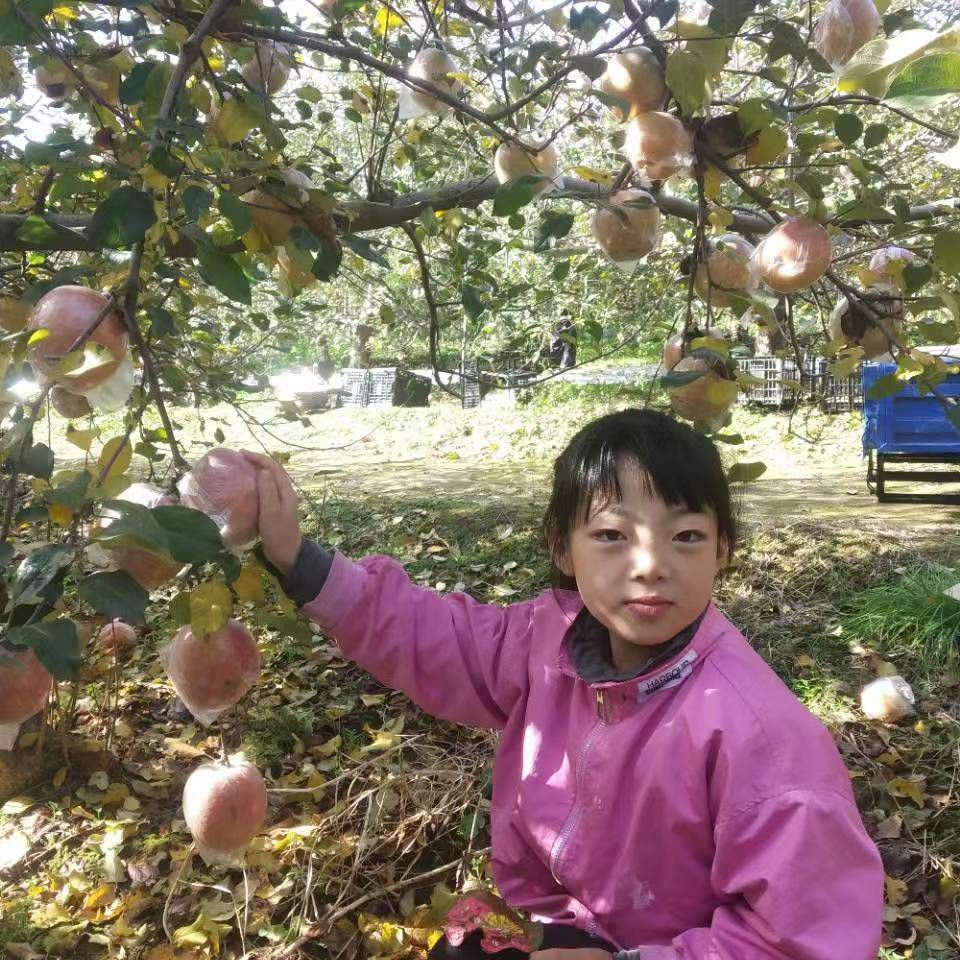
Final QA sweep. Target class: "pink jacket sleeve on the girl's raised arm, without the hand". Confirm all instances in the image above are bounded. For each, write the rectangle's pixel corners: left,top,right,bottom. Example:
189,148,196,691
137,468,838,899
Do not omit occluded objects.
303,553,534,728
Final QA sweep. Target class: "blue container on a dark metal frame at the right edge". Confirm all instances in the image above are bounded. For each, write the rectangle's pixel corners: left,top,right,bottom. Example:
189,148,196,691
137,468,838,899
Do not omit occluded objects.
863,357,960,455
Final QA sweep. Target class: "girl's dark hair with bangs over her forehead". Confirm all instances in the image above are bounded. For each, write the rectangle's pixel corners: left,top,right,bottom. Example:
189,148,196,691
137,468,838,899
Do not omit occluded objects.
543,409,737,590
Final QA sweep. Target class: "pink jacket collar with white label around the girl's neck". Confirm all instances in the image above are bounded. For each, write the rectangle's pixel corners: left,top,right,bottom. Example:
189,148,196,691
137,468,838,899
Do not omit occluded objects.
548,590,727,700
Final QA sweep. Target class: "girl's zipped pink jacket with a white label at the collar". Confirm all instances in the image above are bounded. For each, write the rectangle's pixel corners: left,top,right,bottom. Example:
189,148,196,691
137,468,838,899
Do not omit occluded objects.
304,553,884,960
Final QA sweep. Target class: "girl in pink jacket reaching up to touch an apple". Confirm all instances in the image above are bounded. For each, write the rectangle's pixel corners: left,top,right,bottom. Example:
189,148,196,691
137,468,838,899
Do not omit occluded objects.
248,410,883,960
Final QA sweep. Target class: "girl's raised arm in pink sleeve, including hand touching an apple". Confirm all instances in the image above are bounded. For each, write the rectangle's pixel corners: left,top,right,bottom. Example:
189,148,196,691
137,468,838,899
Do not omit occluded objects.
244,450,533,728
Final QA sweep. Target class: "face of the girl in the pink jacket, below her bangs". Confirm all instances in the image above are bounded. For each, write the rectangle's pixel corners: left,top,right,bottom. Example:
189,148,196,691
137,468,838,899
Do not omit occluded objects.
557,462,724,672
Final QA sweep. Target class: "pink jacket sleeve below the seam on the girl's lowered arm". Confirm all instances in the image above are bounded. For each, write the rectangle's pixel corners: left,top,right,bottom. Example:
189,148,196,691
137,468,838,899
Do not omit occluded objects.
618,790,884,960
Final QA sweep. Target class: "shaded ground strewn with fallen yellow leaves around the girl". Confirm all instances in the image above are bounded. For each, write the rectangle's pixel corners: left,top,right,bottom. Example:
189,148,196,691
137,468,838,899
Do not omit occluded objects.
0,402,960,960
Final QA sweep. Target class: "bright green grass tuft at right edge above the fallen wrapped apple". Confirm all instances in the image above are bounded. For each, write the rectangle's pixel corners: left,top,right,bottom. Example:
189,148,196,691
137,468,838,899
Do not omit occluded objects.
840,564,960,671
